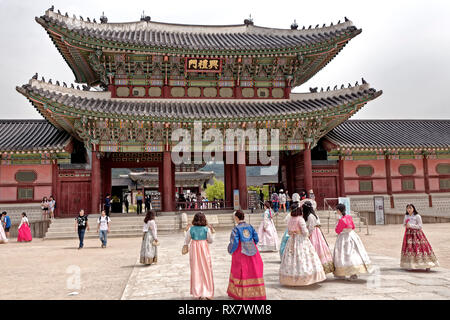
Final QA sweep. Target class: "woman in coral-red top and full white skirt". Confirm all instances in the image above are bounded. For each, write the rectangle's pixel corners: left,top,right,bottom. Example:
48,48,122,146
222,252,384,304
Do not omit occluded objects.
333,203,372,280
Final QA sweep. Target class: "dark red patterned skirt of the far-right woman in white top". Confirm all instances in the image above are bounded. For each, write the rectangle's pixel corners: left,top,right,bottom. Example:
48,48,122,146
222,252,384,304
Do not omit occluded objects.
400,228,439,269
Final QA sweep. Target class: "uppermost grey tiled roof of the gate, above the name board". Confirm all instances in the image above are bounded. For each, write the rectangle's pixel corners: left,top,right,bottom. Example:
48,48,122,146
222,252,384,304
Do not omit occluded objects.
36,10,361,50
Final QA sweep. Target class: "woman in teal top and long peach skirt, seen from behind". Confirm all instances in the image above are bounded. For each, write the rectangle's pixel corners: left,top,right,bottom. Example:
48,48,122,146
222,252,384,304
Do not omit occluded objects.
183,212,215,300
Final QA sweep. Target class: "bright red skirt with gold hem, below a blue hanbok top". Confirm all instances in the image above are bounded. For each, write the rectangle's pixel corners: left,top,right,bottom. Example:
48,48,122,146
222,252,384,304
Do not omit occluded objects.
227,242,266,300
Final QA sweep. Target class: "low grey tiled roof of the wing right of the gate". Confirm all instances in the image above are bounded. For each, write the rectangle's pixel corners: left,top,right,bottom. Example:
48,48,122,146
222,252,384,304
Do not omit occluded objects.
325,120,450,149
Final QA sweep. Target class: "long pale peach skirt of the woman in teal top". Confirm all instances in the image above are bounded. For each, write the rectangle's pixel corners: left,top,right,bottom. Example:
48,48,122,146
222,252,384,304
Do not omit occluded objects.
189,240,214,298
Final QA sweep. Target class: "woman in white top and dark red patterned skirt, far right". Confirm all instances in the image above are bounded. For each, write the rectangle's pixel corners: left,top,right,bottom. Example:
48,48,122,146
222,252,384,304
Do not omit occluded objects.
400,204,439,271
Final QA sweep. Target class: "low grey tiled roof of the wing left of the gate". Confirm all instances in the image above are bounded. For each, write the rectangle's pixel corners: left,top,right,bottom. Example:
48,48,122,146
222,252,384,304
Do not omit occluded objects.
0,120,71,151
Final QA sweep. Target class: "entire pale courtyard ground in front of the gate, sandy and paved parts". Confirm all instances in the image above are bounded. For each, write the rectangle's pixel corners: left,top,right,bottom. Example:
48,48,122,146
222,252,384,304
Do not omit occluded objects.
0,223,450,300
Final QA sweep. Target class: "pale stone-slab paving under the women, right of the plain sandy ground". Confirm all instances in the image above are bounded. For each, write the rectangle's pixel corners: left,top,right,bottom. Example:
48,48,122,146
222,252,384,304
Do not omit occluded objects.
121,230,450,300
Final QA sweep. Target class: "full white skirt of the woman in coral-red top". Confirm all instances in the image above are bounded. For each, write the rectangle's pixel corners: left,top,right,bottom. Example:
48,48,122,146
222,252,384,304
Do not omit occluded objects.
333,230,372,277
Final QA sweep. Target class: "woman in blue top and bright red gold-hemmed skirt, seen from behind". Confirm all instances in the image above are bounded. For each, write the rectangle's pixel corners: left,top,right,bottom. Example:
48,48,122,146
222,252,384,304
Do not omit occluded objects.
227,210,266,300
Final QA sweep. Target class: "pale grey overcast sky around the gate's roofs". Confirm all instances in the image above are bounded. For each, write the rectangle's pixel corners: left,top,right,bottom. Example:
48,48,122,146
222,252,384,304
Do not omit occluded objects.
0,0,450,119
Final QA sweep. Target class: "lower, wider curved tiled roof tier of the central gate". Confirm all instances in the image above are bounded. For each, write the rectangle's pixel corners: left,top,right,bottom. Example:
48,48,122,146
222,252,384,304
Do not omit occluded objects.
16,79,382,120
